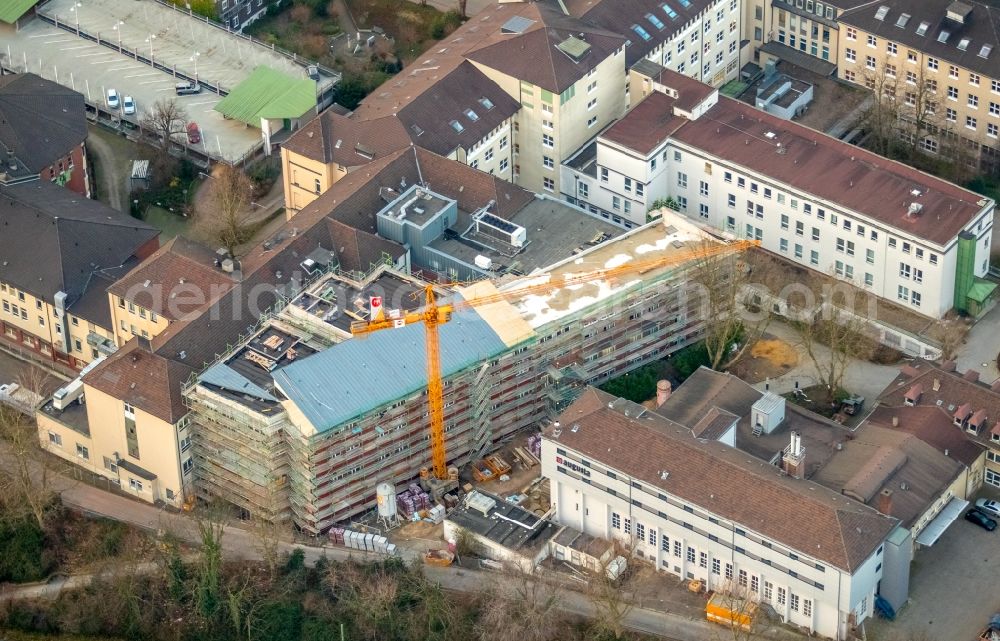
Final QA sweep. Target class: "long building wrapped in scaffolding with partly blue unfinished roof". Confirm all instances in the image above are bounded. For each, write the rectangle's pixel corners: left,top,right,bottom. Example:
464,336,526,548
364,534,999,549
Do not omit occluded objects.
184,199,728,533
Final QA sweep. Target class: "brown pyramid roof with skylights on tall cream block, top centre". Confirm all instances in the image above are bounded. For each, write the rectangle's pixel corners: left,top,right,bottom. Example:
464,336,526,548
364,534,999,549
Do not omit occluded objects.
466,2,624,94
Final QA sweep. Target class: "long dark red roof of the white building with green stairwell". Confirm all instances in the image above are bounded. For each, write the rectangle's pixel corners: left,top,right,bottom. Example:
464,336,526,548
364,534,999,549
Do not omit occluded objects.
673,96,985,245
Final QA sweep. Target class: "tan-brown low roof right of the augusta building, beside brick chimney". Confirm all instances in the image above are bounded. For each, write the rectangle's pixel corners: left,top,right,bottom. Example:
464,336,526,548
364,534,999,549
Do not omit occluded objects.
811,425,963,527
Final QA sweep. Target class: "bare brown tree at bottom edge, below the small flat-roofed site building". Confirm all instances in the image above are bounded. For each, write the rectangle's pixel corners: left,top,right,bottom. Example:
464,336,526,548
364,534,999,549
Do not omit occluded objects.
476,564,563,641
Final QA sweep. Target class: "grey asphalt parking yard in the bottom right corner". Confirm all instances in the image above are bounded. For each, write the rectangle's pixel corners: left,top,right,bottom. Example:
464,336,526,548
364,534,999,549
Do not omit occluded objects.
889,492,1000,641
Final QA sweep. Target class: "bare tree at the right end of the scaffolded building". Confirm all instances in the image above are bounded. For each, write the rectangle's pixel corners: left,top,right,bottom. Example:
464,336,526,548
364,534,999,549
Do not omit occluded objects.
689,241,773,370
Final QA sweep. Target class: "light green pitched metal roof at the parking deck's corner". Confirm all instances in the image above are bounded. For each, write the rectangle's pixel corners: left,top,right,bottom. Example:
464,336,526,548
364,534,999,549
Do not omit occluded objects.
215,65,316,127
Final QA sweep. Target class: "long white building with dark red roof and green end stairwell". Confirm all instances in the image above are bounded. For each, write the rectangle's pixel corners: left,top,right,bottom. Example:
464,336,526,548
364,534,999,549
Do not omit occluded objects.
561,64,995,318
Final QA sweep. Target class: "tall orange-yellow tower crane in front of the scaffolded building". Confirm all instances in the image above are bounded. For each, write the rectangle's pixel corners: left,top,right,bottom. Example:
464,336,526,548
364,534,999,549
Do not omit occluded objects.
351,240,760,480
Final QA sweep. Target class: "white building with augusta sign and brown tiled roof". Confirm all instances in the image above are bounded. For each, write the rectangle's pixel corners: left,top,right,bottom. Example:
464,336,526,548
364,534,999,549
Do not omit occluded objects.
541,388,910,639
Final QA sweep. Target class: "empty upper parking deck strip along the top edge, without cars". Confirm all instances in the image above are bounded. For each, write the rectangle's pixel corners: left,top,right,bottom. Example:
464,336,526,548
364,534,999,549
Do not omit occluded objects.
39,0,334,91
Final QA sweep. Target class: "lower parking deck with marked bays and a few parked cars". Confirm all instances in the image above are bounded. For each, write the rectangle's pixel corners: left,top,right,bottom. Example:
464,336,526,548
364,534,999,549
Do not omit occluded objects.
0,19,261,160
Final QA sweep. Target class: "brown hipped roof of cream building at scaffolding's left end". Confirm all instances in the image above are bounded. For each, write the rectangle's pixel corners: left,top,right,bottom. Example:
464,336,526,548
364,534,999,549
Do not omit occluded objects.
83,338,194,424
